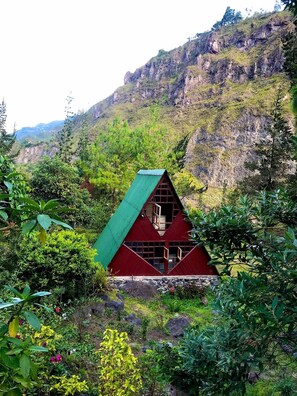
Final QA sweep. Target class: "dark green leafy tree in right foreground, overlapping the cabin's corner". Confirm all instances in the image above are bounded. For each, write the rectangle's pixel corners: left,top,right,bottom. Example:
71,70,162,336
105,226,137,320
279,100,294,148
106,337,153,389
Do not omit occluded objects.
162,192,297,395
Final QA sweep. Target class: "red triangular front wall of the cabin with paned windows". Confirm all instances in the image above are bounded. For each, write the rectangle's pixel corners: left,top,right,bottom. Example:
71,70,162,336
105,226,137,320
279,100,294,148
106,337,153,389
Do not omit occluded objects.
108,174,217,276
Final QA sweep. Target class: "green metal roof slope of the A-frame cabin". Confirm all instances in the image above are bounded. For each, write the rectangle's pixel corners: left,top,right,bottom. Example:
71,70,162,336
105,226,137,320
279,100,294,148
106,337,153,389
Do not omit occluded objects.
94,169,165,268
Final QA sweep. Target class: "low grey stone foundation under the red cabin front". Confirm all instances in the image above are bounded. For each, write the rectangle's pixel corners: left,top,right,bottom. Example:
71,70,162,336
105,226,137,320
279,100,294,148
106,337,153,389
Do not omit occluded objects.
108,275,219,293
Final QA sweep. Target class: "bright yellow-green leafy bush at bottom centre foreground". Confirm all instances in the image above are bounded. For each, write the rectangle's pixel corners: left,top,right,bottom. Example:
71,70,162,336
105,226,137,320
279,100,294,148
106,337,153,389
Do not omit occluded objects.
98,329,142,396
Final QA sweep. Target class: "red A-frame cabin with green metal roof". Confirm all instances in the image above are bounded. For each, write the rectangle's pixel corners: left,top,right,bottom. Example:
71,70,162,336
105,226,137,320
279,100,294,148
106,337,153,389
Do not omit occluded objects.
94,169,217,276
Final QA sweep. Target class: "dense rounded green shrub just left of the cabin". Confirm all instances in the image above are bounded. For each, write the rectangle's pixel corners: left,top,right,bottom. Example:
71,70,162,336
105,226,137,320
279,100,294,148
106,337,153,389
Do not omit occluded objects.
18,231,95,300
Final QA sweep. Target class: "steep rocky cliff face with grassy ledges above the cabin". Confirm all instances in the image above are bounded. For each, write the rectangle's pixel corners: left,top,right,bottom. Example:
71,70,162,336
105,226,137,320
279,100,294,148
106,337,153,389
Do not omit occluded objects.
90,13,291,186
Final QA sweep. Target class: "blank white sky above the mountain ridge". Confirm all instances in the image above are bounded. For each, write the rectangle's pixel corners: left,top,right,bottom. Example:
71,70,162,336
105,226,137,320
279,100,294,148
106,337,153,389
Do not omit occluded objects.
0,0,275,131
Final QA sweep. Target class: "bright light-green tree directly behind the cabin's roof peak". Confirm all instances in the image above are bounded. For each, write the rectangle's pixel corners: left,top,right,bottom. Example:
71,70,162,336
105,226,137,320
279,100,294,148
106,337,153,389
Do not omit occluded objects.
82,108,175,208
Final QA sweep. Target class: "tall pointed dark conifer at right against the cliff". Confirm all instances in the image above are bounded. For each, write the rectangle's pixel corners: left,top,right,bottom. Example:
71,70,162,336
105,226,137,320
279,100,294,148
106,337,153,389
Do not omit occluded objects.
240,91,294,193
